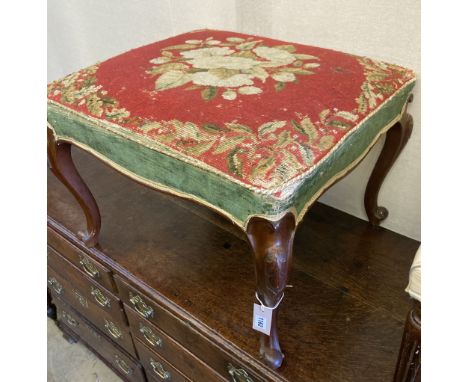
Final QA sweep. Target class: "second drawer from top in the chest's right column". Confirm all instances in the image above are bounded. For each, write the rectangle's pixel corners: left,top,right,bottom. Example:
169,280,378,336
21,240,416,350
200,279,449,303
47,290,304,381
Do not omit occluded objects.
125,307,226,382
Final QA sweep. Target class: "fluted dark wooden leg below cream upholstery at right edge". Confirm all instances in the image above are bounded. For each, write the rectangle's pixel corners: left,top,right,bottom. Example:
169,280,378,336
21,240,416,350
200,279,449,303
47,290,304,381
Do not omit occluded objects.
393,302,421,382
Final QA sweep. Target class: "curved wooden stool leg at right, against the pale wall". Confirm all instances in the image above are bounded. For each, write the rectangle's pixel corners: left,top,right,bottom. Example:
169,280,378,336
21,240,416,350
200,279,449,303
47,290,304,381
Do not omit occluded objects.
364,98,413,226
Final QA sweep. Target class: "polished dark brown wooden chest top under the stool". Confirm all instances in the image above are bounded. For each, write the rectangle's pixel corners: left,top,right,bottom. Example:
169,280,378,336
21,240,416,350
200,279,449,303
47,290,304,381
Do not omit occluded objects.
48,150,419,382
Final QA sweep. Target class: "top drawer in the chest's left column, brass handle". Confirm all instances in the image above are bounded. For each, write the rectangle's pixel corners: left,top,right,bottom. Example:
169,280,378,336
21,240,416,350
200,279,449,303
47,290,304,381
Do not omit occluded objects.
47,228,117,292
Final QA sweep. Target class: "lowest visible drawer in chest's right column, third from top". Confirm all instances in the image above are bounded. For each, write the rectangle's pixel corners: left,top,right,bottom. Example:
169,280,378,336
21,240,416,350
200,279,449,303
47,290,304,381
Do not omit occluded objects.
135,340,188,382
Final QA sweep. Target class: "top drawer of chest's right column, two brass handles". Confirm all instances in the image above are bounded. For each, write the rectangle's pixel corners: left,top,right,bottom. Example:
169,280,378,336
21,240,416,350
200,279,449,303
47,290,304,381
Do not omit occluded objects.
115,276,264,382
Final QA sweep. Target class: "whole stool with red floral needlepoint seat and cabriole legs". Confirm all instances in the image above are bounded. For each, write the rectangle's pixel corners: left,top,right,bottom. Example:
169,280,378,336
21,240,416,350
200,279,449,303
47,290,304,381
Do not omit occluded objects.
48,30,415,367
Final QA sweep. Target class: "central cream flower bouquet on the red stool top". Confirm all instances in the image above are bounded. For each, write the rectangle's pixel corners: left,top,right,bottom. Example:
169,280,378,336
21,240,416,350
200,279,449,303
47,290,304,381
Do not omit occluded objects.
147,37,320,101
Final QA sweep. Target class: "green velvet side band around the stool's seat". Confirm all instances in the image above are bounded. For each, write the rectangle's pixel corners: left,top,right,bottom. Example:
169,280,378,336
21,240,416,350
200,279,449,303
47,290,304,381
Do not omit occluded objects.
47,83,414,226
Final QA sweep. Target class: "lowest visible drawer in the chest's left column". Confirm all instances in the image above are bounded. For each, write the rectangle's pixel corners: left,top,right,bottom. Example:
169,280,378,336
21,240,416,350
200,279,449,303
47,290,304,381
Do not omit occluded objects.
54,298,145,382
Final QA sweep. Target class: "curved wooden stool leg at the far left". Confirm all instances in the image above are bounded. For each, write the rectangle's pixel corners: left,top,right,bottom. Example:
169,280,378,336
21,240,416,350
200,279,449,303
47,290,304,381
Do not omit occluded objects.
47,129,101,247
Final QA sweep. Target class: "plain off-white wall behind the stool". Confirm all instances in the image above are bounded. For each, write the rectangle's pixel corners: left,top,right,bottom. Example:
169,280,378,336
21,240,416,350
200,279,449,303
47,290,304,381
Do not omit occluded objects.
48,0,421,239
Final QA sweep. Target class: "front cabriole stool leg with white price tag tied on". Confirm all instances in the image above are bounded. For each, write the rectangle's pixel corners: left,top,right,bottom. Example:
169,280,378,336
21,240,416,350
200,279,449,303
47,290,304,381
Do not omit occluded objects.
247,213,296,369
